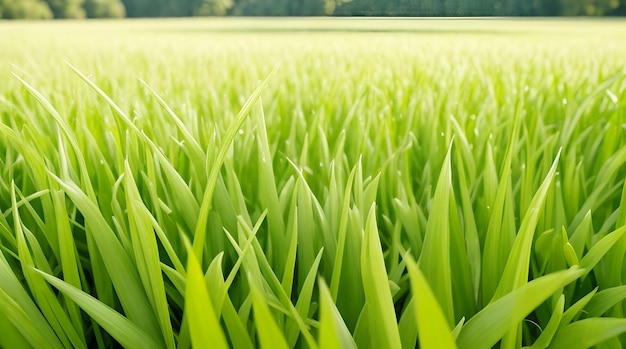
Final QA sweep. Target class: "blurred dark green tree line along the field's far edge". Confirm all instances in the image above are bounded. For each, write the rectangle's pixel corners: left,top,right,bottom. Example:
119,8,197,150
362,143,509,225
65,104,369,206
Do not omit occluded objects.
0,0,626,19
